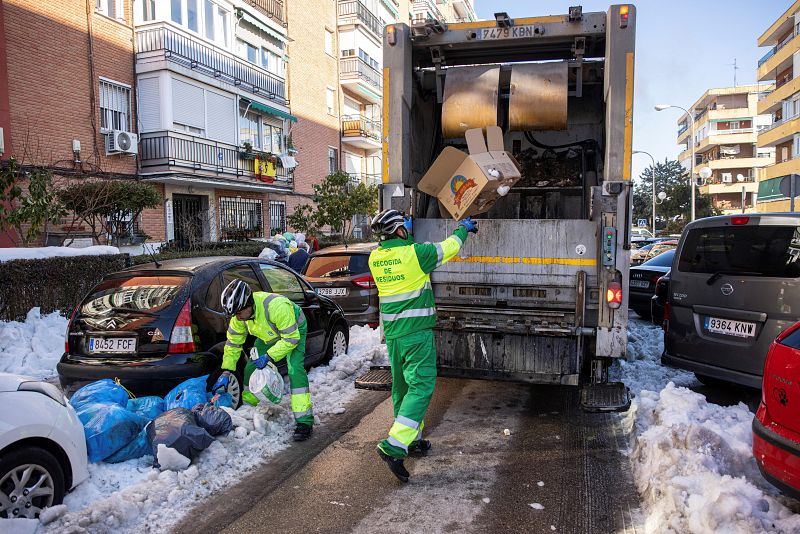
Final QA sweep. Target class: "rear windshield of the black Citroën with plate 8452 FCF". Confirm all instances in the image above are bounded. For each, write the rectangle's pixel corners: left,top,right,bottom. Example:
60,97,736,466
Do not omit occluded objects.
81,275,190,315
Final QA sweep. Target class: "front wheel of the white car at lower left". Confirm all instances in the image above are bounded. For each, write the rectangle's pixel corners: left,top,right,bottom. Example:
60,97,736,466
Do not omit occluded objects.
0,447,66,519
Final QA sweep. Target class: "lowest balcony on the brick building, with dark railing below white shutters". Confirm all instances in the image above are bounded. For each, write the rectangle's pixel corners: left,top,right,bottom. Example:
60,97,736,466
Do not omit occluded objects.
139,132,293,190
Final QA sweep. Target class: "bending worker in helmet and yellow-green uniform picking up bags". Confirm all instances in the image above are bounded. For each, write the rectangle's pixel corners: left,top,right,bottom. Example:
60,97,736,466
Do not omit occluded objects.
212,280,314,441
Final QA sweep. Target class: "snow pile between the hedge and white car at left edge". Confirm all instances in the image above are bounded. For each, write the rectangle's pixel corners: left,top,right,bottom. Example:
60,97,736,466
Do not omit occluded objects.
0,308,67,378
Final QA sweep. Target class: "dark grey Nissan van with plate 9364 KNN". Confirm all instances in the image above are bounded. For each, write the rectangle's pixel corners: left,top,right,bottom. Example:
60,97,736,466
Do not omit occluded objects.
661,213,800,388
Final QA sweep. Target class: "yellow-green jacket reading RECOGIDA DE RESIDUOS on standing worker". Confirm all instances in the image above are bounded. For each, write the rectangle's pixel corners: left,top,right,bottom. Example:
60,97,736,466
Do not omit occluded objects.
369,226,467,339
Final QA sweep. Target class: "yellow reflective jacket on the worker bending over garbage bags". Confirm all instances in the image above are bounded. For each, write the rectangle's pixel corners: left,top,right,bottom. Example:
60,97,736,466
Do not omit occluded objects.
222,291,306,371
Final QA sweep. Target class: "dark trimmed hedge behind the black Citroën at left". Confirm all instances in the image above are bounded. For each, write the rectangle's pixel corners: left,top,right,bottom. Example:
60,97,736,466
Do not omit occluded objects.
0,254,129,321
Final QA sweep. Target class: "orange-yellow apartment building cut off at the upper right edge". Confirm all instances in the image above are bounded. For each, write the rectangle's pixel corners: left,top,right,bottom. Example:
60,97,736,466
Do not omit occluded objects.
757,0,800,212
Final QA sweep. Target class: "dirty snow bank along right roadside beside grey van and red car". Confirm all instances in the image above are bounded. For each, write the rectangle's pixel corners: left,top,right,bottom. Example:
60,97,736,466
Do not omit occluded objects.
615,320,800,534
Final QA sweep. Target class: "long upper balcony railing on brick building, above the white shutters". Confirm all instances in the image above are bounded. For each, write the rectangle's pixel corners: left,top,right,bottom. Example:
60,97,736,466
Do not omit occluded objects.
136,26,289,105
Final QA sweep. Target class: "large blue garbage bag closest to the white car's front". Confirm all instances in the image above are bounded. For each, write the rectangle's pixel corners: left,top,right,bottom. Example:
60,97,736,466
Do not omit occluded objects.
77,403,147,462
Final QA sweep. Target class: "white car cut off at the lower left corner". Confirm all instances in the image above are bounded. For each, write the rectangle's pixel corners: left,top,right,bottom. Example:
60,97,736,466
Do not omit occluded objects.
0,373,89,519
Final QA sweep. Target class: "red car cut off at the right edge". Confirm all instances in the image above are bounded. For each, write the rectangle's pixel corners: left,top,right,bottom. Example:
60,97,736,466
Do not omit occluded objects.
753,322,800,498
